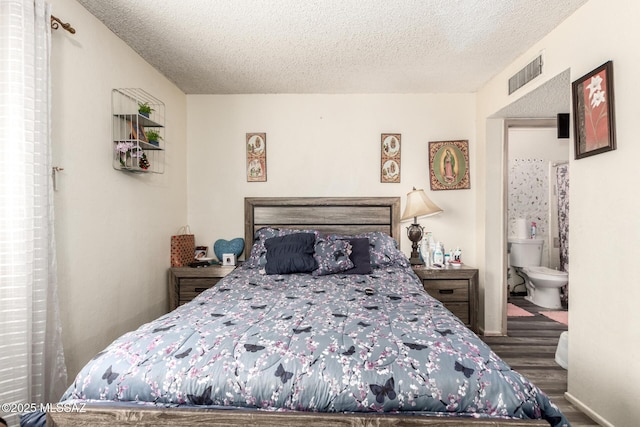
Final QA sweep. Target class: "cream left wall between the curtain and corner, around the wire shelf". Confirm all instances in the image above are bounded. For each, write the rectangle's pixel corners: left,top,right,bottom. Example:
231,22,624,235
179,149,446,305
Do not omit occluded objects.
51,0,187,381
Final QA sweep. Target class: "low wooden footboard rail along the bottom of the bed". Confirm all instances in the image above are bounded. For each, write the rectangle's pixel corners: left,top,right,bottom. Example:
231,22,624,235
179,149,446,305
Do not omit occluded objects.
47,405,549,427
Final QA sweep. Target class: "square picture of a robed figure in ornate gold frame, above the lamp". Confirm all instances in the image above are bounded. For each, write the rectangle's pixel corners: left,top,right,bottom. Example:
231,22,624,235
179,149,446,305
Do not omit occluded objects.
429,140,471,190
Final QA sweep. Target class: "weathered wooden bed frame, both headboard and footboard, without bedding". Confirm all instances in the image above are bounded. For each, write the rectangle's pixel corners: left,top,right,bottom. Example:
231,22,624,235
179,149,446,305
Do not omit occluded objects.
47,197,549,427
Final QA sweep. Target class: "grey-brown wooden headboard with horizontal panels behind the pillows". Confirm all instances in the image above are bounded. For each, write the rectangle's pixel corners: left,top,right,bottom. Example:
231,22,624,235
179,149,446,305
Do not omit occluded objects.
244,197,400,259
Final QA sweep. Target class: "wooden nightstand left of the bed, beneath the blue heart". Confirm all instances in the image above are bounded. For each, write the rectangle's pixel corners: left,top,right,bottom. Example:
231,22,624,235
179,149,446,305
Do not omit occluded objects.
169,265,236,311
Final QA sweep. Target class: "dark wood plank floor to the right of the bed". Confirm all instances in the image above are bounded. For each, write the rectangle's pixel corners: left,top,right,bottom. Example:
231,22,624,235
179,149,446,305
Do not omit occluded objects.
482,297,598,427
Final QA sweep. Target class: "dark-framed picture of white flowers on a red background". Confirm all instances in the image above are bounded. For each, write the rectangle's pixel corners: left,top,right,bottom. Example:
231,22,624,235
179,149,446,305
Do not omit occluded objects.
571,61,616,159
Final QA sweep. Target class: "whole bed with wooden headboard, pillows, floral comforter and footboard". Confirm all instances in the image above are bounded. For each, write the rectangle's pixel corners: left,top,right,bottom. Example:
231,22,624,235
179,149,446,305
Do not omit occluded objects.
42,197,569,426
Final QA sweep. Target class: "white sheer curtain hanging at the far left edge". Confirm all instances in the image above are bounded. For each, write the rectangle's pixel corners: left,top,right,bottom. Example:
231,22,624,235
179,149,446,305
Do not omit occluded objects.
0,0,66,424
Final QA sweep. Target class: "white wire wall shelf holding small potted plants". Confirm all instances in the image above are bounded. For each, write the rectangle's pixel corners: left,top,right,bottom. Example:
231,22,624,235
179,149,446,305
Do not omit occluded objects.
111,89,165,173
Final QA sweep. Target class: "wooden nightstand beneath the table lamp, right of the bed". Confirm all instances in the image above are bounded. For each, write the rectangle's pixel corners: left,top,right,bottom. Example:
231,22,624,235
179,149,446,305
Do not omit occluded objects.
413,265,479,333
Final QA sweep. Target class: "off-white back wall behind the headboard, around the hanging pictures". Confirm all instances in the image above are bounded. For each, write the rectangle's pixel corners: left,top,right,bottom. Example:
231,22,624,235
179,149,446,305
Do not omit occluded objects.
187,94,478,265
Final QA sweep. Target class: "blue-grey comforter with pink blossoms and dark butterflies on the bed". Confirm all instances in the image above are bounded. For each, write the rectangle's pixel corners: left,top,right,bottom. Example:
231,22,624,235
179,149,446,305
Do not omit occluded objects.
63,266,568,425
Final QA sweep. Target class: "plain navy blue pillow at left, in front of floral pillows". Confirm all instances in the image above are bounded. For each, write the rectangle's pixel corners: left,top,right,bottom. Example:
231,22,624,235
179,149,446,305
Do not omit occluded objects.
264,233,318,274
